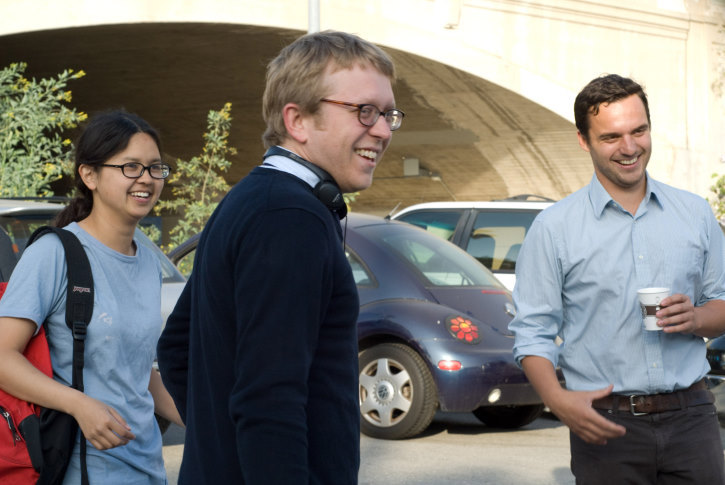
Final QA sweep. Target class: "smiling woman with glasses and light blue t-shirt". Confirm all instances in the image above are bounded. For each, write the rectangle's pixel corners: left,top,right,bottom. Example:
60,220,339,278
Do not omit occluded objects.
0,111,181,485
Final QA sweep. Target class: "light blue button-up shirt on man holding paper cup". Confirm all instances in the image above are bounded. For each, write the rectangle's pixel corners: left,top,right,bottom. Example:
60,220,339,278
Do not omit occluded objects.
509,176,725,394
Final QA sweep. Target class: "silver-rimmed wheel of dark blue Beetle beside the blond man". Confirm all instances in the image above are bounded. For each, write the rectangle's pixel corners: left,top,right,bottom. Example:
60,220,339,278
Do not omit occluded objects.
359,344,438,439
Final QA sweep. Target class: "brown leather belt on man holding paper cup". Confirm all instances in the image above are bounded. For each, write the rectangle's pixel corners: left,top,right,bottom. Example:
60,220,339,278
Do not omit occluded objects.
592,379,715,416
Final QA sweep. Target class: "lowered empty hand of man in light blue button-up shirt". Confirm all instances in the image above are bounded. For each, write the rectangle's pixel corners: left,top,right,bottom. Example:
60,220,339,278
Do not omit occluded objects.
547,384,626,445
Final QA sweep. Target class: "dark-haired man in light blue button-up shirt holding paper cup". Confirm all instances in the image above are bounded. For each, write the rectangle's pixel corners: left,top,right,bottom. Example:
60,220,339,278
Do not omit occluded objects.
510,75,725,484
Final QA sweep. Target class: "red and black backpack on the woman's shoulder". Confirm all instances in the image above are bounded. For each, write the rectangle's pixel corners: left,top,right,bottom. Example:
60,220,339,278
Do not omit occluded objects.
0,226,93,485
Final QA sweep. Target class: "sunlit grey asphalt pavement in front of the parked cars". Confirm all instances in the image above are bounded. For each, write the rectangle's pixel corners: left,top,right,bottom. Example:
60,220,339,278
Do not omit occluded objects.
164,413,574,485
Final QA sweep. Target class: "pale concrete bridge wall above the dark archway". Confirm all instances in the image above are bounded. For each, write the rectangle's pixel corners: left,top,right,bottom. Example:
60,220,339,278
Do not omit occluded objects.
0,0,725,195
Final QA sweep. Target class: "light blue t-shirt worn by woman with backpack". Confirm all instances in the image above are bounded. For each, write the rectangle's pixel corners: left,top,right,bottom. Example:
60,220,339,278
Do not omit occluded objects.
0,223,166,485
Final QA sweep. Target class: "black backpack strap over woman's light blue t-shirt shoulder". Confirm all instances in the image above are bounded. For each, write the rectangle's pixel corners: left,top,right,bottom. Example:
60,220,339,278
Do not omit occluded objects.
26,226,93,485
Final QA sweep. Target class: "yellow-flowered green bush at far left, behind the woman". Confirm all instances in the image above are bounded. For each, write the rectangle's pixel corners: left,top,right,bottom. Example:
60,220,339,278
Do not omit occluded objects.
0,62,87,197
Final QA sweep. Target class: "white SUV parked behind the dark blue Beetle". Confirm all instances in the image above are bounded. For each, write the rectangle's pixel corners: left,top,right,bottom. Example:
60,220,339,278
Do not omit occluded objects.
391,194,554,290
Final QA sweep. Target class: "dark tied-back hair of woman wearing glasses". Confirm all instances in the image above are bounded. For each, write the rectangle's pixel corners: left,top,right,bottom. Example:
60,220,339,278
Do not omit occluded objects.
54,110,161,227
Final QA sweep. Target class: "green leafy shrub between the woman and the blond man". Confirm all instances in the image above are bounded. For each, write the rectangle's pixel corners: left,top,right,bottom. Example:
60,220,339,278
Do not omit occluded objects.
155,103,237,271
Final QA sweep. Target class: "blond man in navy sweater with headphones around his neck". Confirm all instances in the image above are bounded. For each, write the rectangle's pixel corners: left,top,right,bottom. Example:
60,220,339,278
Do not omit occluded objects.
158,31,403,485
